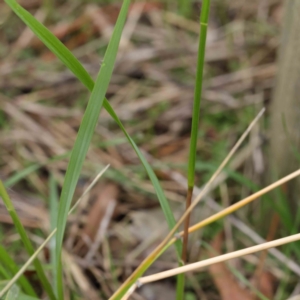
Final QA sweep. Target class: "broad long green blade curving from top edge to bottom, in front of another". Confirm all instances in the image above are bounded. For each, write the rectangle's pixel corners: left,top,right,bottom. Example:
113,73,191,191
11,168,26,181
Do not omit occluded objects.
56,0,130,300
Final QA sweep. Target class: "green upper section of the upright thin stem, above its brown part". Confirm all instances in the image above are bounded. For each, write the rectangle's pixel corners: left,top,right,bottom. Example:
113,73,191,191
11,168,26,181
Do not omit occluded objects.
188,0,210,188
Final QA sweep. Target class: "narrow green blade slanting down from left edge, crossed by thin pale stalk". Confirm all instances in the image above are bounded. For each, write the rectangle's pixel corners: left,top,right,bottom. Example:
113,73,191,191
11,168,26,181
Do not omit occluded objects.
0,180,56,300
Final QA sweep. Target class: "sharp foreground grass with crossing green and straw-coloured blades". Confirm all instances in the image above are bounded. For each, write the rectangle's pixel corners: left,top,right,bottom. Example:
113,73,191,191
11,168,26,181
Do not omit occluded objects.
0,0,300,300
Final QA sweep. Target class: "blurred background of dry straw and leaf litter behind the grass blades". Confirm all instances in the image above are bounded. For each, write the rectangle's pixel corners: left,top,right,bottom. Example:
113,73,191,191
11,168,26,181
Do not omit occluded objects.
0,0,300,300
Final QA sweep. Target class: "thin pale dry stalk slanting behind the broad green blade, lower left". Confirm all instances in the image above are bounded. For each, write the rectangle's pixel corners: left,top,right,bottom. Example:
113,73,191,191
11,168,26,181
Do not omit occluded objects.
0,165,109,299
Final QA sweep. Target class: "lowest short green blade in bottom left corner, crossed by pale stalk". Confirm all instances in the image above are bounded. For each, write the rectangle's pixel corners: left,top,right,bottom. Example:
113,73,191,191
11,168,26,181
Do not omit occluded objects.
0,245,37,297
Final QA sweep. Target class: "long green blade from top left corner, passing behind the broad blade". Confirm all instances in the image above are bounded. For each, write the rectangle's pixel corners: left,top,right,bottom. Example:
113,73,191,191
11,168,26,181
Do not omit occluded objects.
5,0,181,258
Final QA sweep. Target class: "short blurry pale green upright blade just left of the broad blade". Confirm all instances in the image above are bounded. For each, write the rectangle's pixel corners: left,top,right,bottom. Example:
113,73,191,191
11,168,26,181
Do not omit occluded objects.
49,174,58,291
